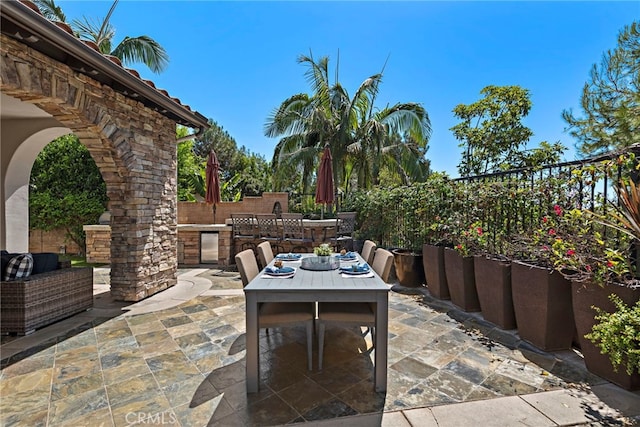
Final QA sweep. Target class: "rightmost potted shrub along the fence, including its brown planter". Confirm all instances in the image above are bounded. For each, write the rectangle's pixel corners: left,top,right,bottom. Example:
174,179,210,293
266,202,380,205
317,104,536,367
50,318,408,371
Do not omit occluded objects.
551,175,640,389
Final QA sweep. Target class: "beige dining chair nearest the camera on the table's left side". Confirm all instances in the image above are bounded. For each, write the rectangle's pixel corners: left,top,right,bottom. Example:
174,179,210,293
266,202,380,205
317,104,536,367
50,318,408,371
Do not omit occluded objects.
235,249,315,371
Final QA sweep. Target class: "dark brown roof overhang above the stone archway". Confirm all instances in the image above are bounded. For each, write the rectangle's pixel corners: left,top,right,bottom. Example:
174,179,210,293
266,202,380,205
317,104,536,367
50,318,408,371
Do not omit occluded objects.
0,0,209,131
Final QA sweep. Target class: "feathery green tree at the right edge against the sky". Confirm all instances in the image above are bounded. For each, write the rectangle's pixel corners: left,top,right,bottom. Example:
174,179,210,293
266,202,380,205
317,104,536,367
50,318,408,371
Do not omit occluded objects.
562,22,640,156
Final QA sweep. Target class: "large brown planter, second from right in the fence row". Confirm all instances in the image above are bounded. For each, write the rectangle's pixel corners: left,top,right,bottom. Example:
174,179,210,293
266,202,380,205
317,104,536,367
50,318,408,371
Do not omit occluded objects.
511,261,575,351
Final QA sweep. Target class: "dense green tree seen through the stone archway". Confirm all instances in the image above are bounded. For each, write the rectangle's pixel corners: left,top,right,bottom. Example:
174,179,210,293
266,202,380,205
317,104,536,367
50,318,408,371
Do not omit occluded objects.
29,134,107,250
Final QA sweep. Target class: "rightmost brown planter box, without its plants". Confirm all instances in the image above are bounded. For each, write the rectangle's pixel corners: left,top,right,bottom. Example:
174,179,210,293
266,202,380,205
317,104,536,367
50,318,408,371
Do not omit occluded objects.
571,281,640,390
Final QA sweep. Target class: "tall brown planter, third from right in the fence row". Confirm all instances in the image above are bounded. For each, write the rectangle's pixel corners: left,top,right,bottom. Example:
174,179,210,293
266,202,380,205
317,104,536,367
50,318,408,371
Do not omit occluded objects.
473,255,516,329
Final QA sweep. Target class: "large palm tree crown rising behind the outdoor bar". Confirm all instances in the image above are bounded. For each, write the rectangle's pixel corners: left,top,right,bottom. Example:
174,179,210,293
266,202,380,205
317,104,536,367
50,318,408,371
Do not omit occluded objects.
265,56,431,192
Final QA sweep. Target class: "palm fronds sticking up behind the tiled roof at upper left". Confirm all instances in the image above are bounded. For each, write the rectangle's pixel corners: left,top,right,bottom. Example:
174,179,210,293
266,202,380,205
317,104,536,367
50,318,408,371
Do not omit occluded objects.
35,0,169,73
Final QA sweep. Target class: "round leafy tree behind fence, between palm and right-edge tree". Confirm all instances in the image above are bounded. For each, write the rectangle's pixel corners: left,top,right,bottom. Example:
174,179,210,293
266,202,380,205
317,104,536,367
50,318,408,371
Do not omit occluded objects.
450,86,533,176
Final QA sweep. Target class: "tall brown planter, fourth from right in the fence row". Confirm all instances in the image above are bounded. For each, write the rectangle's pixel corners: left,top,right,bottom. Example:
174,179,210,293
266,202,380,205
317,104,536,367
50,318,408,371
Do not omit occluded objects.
444,248,480,312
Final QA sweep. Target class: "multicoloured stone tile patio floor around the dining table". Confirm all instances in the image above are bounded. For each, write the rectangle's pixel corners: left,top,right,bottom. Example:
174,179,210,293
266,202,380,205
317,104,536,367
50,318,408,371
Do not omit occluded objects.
0,268,640,427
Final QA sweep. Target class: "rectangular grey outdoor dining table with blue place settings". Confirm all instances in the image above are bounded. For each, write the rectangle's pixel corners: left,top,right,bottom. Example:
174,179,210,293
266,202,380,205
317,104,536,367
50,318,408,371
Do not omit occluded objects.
244,254,389,393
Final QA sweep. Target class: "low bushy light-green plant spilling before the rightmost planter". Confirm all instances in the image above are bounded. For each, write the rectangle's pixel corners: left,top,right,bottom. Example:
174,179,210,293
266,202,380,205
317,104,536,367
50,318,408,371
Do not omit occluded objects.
585,294,640,375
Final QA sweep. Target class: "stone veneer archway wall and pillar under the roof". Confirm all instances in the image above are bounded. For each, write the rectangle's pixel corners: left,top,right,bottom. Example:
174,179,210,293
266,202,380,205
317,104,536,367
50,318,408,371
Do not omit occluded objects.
0,35,177,301
